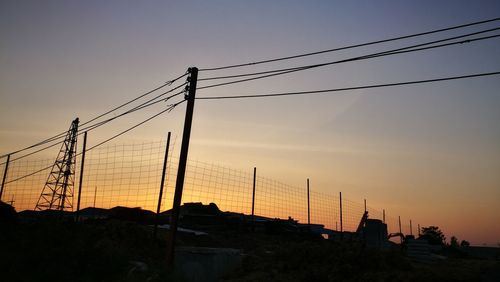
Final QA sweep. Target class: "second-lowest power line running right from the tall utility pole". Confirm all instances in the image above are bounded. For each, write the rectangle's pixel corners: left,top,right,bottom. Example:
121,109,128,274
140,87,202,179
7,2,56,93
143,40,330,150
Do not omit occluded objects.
198,32,500,90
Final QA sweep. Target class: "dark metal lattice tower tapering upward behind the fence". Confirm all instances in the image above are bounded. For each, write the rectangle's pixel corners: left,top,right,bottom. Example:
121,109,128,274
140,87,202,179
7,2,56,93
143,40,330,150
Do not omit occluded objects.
35,118,79,211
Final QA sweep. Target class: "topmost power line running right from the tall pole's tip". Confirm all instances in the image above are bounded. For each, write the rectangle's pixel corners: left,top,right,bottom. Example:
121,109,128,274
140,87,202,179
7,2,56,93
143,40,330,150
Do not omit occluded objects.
200,18,500,71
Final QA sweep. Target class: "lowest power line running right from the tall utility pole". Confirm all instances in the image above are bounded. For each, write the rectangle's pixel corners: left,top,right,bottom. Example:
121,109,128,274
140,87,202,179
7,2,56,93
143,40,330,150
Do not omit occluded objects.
196,71,500,100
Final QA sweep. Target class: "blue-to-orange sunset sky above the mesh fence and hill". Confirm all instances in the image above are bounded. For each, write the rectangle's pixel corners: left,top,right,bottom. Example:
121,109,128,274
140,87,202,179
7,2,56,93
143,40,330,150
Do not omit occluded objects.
0,0,500,244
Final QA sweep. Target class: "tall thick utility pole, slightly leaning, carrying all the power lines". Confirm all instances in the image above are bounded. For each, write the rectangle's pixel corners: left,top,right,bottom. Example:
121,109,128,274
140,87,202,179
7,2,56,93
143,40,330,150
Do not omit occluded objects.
166,67,198,267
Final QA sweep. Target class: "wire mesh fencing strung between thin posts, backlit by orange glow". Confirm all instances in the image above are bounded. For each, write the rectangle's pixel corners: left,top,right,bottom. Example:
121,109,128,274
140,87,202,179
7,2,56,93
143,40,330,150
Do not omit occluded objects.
0,140,418,235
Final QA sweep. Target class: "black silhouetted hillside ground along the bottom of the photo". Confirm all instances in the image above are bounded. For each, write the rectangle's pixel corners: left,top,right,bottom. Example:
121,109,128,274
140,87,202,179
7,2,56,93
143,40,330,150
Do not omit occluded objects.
0,202,500,281
